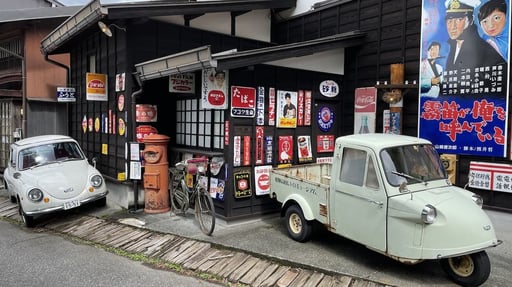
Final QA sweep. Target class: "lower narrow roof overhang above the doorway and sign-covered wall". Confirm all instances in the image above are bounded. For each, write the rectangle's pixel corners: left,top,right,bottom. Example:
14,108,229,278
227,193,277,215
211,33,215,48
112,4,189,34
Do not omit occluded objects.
135,31,366,81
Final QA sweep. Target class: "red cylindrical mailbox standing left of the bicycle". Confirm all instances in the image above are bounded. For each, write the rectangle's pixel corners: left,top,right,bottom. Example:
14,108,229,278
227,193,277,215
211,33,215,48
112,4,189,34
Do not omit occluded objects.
143,134,170,213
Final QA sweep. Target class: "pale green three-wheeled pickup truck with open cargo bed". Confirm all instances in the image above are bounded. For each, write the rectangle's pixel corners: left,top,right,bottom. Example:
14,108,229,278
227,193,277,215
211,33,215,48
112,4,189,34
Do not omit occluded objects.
270,134,501,286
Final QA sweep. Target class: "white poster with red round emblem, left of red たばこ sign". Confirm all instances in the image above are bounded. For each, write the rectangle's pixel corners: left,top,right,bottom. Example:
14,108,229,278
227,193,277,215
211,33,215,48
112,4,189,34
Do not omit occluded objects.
199,68,229,110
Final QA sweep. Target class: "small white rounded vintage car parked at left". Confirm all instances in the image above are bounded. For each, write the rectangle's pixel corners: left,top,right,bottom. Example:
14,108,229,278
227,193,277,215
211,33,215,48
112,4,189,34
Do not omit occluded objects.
4,135,108,227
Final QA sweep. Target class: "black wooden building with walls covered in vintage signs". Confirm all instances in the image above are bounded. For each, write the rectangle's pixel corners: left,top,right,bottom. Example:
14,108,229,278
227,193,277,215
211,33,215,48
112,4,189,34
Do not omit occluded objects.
41,0,511,220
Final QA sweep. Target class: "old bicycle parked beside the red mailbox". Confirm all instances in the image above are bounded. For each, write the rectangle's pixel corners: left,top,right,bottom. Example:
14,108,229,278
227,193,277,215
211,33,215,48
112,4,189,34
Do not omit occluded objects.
169,158,215,235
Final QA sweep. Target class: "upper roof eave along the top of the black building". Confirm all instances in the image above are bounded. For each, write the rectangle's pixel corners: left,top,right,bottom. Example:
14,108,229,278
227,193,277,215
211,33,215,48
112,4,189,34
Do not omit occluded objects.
41,0,296,55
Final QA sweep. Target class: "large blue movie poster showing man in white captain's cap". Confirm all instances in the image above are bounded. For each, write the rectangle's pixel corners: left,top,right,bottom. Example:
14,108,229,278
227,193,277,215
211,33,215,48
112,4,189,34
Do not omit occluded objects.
418,0,510,157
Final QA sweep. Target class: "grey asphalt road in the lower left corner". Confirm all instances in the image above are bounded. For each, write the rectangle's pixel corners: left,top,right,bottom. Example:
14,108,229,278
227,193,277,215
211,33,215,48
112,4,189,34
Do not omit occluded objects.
0,221,225,287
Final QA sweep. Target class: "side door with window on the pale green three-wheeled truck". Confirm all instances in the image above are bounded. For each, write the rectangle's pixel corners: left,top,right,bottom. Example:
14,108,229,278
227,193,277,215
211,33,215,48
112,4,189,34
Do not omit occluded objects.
330,147,387,251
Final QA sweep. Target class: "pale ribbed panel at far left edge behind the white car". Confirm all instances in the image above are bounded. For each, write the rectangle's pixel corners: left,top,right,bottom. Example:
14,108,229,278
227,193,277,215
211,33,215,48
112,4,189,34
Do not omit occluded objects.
0,99,21,172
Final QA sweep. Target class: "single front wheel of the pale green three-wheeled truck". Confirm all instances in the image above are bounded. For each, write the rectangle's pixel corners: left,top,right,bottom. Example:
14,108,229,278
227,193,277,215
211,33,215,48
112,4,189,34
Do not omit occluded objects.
441,251,491,286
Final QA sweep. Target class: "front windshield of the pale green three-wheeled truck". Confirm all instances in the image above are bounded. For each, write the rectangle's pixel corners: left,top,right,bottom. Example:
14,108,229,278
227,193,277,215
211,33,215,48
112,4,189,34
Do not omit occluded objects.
380,145,447,186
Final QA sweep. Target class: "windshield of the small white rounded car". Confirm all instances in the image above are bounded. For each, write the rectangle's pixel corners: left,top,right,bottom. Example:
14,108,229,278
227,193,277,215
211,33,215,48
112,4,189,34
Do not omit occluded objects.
18,142,85,170
